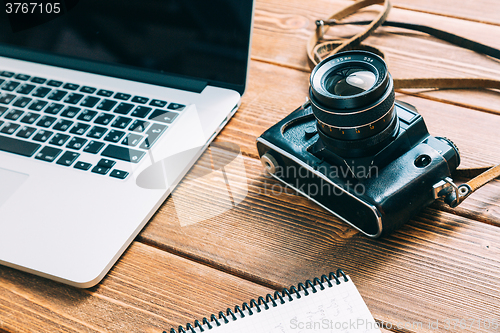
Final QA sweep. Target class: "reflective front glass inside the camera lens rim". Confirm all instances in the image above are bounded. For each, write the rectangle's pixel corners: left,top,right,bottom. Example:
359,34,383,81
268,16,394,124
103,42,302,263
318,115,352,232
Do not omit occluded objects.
324,67,376,96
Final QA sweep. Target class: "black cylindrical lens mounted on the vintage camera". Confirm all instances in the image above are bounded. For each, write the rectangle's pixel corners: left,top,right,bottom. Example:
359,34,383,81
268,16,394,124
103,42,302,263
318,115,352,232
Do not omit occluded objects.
309,51,399,157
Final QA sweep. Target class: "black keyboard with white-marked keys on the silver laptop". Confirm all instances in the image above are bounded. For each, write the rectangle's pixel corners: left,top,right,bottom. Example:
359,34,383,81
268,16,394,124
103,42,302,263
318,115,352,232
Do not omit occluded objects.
0,71,186,179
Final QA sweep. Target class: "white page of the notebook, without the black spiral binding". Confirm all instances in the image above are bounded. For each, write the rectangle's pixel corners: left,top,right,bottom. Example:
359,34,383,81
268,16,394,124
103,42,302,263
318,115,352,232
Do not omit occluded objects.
196,278,380,333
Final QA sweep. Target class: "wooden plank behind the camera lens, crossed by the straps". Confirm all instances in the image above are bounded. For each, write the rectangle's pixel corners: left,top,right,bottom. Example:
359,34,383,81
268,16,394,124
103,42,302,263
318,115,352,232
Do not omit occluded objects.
252,0,500,112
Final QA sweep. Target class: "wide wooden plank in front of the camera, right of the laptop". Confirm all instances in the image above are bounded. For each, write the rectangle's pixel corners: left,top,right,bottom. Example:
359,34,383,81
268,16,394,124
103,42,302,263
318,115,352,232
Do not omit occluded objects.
139,149,500,332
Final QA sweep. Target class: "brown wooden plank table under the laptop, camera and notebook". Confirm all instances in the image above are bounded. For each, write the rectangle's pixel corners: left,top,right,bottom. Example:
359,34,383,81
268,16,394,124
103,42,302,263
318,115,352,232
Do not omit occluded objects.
0,0,500,332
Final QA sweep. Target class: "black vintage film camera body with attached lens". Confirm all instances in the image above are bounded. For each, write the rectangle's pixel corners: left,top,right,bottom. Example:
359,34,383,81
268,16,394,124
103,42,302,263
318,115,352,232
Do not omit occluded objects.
257,51,460,237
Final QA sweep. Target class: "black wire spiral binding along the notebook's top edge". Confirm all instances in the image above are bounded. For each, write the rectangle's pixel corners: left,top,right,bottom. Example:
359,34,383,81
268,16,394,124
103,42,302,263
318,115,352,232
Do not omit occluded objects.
167,269,349,333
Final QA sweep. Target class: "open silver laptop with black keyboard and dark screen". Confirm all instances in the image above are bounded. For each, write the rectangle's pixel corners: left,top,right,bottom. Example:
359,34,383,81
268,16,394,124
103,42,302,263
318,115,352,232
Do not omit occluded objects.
0,0,254,288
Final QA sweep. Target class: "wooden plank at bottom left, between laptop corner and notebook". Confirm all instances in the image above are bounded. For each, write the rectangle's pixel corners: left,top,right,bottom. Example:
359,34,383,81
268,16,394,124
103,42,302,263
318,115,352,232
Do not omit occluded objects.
0,242,273,332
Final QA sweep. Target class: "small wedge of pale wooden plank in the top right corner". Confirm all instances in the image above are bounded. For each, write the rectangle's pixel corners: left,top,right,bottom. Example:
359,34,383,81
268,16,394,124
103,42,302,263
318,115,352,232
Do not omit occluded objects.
391,0,500,25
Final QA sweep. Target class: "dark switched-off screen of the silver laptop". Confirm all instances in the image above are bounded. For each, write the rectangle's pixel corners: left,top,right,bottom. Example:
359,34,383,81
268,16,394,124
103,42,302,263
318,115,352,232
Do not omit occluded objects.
0,0,253,93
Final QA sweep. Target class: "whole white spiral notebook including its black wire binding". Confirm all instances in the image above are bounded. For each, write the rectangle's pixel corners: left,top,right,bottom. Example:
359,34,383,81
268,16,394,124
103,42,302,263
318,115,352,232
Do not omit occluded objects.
168,269,380,333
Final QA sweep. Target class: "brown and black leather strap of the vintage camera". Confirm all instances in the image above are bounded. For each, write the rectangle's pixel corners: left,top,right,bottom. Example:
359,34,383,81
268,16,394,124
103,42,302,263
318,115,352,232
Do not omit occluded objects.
307,0,500,208
